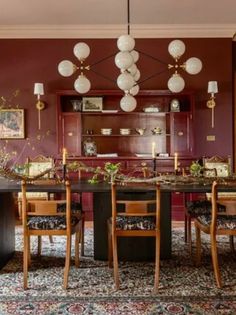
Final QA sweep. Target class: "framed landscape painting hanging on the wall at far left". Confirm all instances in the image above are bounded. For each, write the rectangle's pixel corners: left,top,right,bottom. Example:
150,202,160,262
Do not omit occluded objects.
0,109,25,139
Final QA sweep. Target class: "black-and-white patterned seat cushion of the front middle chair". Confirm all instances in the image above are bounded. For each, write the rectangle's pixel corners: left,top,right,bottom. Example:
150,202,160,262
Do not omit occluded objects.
116,216,156,230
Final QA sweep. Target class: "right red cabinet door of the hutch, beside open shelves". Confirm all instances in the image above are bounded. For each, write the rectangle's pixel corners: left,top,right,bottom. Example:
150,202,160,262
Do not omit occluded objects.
171,112,193,156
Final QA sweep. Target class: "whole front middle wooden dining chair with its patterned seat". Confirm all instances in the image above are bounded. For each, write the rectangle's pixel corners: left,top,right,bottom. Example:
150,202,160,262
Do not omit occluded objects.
107,182,161,292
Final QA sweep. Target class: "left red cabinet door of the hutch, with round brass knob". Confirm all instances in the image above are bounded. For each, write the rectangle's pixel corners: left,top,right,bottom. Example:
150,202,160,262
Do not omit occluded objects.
62,113,81,155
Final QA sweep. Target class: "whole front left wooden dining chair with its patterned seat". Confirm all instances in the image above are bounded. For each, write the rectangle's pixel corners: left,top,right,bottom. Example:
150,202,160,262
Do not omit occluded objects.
22,181,82,289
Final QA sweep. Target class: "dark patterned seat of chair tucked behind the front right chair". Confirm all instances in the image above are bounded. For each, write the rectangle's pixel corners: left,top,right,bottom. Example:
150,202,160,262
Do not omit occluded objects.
186,200,226,216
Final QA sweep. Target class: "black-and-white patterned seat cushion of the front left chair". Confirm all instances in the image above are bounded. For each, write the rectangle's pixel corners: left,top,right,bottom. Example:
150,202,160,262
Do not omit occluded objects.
27,215,80,230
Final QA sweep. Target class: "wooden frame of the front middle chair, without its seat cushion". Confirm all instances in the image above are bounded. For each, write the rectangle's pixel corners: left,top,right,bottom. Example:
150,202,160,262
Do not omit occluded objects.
108,183,160,292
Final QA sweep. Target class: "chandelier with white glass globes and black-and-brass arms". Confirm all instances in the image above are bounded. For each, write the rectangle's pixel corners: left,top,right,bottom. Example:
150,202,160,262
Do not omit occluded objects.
58,0,202,111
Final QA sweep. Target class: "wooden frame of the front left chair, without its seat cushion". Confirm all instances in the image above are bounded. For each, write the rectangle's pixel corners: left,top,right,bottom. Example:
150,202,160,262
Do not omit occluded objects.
22,181,82,289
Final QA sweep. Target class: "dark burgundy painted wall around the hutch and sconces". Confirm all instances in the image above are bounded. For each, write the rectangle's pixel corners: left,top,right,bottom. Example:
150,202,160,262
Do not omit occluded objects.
0,38,233,165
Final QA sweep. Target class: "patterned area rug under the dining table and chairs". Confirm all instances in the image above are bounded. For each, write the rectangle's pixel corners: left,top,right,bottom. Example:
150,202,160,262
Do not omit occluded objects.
0,227,236,315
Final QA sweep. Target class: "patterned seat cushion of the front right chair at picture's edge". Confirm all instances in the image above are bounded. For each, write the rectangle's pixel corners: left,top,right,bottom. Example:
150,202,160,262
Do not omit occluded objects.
197,214,236,230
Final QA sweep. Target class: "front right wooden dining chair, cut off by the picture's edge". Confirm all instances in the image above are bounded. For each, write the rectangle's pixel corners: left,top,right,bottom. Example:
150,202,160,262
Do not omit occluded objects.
194,181,236,288
